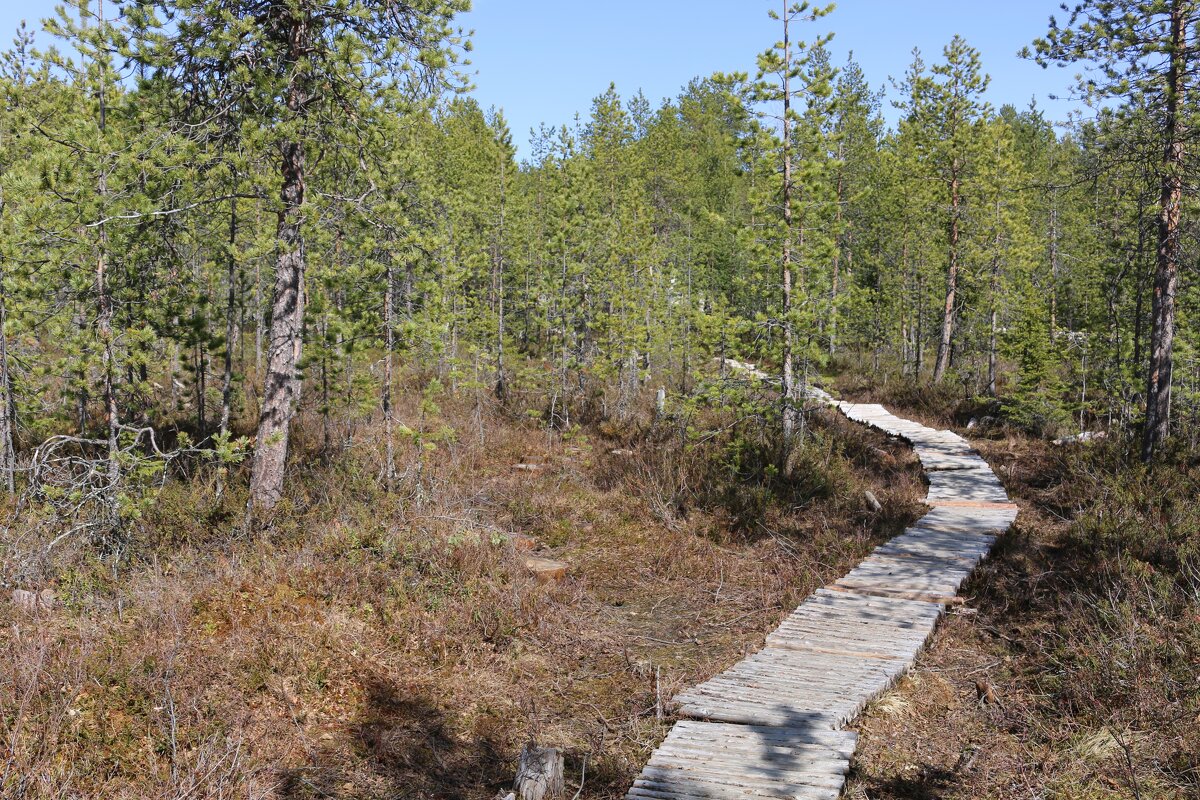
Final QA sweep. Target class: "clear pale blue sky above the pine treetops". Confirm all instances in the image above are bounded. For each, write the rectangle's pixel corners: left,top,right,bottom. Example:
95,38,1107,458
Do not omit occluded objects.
0,0,1086,156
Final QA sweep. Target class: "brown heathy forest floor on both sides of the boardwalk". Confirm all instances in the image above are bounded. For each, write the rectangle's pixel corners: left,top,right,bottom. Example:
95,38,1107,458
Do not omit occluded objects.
0,380,1200,800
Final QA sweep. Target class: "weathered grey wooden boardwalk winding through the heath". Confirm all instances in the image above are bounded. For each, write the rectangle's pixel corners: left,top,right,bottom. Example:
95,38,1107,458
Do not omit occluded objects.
625,393,1016,800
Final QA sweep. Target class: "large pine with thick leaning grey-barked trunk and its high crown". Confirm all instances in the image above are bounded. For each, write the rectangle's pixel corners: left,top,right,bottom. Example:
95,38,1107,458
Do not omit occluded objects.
141,0,468,511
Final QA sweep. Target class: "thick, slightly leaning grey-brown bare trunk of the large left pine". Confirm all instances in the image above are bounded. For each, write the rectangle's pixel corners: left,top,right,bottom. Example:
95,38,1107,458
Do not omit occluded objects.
250,142,305,511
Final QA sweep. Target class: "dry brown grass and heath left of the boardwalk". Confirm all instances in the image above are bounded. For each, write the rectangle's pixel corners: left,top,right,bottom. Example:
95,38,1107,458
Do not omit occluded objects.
0,383,922,799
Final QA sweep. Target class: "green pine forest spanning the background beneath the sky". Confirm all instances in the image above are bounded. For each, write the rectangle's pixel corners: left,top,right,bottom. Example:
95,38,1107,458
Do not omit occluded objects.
0,0,1200,544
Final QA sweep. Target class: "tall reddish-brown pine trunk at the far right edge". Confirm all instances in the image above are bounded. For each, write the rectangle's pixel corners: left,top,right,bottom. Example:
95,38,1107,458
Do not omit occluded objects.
1141,0,1189,463
